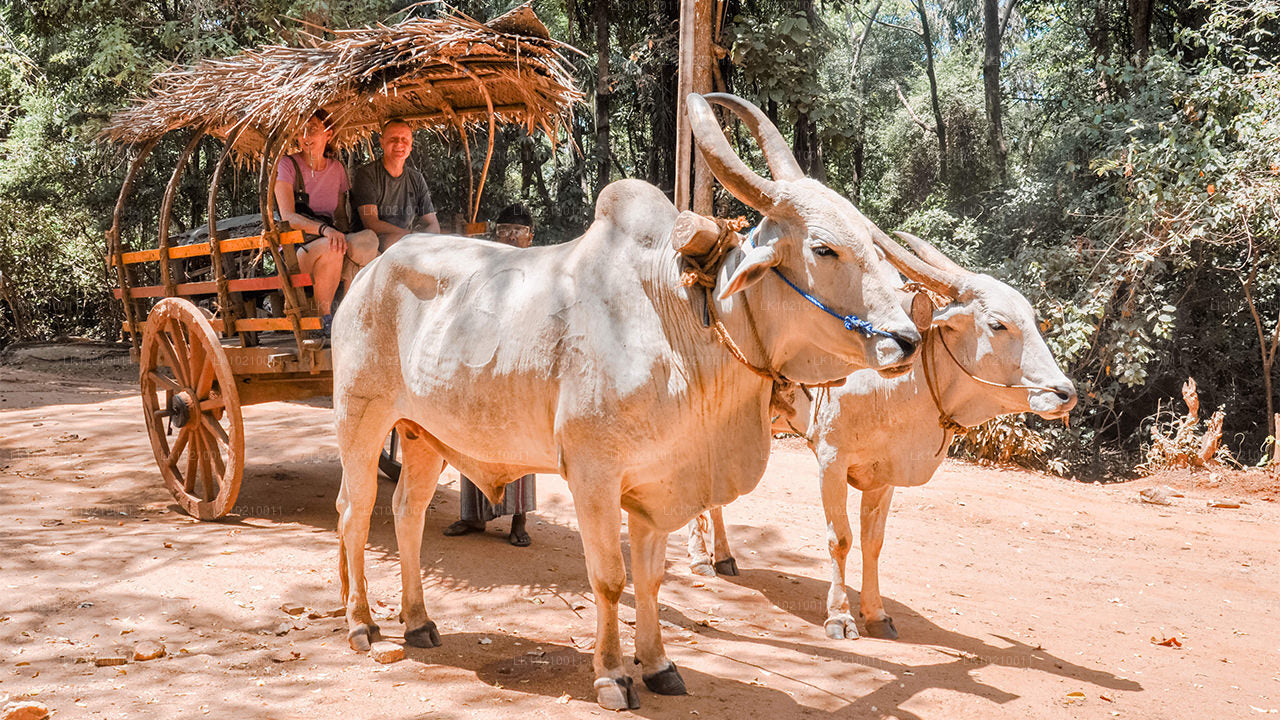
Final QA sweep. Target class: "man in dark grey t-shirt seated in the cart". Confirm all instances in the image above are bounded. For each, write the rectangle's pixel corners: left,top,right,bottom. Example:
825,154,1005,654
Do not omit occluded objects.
352,120,440,250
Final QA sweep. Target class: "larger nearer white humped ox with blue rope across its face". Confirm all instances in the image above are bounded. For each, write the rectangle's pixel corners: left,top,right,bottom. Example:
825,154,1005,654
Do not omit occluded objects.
333,95,920,708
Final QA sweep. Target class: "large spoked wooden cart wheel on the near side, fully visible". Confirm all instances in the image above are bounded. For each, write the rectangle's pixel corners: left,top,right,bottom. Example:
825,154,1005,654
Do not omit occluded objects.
141,297,244,520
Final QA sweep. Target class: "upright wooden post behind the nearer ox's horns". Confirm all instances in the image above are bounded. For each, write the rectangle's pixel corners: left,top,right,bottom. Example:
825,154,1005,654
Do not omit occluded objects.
676,0,713,215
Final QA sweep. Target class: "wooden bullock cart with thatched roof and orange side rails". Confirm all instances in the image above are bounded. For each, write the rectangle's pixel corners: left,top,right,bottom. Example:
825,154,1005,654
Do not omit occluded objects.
104,6,582,520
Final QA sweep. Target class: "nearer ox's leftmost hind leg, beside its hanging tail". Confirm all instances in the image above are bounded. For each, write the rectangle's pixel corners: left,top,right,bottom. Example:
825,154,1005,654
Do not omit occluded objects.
337,425,387,651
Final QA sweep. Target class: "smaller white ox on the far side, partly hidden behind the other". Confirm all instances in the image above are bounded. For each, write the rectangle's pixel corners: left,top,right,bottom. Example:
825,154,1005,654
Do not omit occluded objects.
689,233,1076,639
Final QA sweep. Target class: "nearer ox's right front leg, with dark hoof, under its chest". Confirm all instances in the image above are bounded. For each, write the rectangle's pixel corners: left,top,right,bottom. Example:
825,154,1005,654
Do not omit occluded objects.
628,518,687,694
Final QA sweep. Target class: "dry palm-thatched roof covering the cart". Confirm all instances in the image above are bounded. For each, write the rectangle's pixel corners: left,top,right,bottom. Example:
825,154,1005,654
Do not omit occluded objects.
102,5,582,158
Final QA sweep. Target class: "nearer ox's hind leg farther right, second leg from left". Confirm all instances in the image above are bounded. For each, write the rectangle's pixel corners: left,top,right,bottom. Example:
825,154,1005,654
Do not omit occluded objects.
392,427,444,647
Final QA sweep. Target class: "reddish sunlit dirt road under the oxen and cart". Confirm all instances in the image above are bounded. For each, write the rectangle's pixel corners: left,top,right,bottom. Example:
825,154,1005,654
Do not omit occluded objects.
0,366,1280,720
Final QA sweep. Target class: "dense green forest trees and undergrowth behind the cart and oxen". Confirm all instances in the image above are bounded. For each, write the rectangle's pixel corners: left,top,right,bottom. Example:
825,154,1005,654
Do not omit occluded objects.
0,0,1280,479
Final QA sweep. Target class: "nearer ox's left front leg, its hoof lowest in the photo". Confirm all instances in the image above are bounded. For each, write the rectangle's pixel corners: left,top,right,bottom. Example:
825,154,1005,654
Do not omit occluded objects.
570,480,640,710
